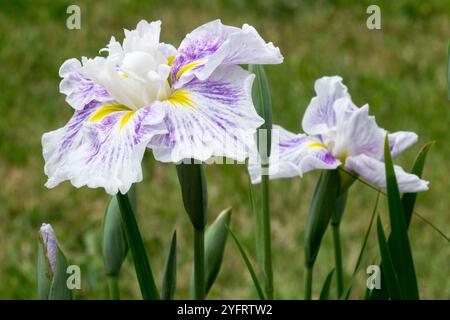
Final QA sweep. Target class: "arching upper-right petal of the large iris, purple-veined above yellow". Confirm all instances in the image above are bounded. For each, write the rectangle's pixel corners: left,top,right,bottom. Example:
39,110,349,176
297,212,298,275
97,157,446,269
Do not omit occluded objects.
172,20,283,88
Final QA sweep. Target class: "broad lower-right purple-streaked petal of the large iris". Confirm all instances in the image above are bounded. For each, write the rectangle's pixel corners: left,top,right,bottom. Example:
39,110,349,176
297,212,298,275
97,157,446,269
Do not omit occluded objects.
149,66,264,163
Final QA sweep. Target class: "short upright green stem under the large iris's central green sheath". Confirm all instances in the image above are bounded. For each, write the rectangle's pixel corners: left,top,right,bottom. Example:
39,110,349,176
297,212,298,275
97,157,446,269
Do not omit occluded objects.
194,228,205,300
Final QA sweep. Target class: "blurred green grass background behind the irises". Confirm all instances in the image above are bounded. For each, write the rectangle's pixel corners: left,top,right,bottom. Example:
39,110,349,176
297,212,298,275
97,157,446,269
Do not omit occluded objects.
0,0,450,299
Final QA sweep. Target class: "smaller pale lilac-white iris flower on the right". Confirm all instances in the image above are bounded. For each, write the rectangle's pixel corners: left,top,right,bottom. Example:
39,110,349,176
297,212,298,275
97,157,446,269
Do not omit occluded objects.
249,76,428,192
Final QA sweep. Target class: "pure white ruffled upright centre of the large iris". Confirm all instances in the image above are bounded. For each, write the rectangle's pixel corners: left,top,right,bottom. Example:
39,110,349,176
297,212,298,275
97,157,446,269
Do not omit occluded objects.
91,20,176,110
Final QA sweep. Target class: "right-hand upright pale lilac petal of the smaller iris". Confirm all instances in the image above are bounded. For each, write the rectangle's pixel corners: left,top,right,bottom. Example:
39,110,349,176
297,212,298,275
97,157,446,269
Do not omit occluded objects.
332,104,385,159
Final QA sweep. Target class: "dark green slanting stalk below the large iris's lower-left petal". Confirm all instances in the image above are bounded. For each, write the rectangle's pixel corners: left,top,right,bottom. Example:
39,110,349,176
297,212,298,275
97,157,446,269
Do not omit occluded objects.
117,192,159,300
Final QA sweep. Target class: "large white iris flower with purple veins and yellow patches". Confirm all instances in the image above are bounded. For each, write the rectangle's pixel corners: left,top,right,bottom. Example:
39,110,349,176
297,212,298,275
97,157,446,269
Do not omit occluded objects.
42,20,283,195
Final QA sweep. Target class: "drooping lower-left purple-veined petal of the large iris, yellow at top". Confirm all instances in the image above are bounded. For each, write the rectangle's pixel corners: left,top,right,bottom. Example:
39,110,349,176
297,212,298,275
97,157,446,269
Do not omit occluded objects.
42,102,167,195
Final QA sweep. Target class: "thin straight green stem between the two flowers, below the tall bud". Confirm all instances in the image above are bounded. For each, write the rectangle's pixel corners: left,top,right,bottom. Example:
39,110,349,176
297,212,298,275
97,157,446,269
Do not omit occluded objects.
261,165,273,300
